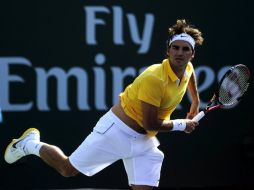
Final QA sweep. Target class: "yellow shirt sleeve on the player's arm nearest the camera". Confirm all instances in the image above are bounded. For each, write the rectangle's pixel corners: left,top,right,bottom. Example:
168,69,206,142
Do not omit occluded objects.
138,75,164,107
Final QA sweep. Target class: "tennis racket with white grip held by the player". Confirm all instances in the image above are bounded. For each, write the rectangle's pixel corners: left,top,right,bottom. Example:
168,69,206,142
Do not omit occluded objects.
192,64,250,121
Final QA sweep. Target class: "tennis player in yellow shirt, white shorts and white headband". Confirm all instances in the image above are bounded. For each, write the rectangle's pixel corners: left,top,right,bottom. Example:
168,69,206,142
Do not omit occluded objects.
4,19,203,190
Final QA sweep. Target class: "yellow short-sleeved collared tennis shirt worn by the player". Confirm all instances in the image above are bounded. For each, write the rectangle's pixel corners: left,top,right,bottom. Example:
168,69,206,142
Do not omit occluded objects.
120,59,193,136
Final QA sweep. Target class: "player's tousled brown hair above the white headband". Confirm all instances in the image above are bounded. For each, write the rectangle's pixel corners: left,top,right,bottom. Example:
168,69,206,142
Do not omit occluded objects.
167,19,204,46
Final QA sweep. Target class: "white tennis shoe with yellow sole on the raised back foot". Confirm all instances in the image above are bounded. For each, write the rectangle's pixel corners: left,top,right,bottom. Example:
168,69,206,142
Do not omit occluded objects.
4,128,40,164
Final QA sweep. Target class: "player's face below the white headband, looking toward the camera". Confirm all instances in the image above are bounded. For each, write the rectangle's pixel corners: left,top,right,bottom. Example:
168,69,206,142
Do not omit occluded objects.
168,40,194,68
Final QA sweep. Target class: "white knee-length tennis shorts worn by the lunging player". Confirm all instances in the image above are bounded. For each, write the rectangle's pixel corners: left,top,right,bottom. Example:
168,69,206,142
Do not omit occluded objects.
69,110,164,187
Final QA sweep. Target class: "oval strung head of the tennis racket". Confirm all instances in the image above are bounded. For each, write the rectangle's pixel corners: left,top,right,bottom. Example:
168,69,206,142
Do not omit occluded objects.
219,66,250,106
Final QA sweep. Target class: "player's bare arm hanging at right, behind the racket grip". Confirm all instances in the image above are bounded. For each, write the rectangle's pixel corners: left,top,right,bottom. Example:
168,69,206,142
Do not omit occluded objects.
186,71,200,119
